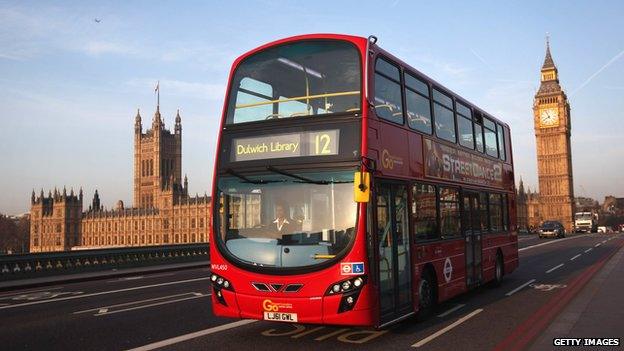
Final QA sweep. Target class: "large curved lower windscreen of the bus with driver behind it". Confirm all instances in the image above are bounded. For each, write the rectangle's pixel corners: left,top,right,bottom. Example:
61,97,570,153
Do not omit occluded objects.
215,172,356,268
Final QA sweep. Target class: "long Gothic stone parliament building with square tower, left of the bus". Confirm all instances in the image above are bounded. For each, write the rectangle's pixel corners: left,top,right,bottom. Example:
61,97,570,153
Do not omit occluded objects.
30,105,211,252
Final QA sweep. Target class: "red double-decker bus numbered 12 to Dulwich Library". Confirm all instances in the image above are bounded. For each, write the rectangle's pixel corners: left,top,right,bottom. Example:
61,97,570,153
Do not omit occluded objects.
210,34,518,327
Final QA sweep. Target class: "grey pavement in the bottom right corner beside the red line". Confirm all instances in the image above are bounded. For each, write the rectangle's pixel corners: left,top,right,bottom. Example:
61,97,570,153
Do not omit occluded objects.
531,238,624,350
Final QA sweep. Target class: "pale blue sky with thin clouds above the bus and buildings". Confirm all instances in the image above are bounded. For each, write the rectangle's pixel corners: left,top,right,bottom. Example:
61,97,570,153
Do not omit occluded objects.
0,0,624,214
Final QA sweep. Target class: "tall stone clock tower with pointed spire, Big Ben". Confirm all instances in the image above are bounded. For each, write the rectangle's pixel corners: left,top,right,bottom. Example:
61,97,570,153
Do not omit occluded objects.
533,40,574,232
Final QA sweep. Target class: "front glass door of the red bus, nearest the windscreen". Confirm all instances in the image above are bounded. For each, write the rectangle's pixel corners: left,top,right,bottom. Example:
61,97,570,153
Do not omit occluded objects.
375,182,413,324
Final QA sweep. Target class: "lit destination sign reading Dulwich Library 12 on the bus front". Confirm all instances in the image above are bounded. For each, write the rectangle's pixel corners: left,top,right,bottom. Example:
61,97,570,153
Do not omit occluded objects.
231,129,340,162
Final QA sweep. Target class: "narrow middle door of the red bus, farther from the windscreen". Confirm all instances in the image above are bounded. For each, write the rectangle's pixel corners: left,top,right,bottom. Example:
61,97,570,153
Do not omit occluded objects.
462,191,482,288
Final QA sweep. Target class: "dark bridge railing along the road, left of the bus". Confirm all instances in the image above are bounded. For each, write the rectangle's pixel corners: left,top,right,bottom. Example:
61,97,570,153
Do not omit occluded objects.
0,243,209,281
